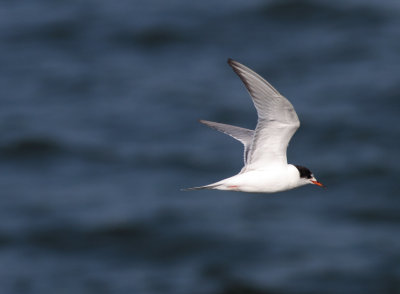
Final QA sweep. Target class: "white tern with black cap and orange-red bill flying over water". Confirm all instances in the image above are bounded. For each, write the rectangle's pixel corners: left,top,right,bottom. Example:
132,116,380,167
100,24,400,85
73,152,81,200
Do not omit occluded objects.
185,59,325,193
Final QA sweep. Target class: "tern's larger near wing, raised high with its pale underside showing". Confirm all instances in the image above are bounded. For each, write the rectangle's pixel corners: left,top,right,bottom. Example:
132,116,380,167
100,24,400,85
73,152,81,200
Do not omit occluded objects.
228,59,300,170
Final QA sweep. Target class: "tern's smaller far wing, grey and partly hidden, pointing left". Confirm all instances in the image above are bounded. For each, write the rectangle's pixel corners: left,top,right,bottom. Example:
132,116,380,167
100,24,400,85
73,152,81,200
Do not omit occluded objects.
199,120,254,165
